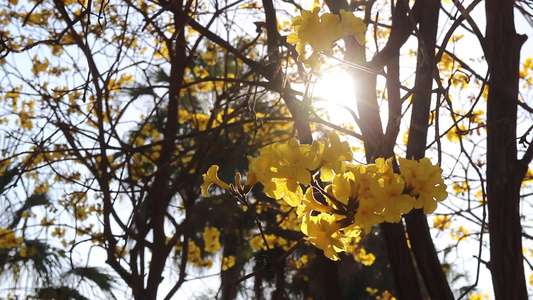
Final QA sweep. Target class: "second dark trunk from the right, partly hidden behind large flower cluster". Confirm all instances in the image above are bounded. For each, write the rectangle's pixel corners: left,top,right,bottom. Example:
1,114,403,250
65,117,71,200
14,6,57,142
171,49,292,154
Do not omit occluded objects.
405,0,454,300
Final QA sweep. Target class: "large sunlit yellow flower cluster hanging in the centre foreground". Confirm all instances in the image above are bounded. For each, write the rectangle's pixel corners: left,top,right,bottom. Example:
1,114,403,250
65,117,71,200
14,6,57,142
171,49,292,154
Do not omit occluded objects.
202,133,448,260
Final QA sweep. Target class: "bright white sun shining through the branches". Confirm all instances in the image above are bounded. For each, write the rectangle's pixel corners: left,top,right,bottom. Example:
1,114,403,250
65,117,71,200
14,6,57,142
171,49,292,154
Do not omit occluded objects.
312,67,356,125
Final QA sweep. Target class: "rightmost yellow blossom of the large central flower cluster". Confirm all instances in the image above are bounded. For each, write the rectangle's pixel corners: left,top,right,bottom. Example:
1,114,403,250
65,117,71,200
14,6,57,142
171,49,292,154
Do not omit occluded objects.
399,158,448,214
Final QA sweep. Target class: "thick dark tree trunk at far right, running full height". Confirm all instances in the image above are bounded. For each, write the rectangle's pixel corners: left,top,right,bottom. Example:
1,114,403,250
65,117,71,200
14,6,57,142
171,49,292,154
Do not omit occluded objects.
484,0,527,299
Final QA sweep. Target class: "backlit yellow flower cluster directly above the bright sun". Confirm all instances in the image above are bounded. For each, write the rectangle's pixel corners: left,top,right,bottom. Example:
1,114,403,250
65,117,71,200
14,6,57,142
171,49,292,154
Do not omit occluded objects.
287,7,366,70
